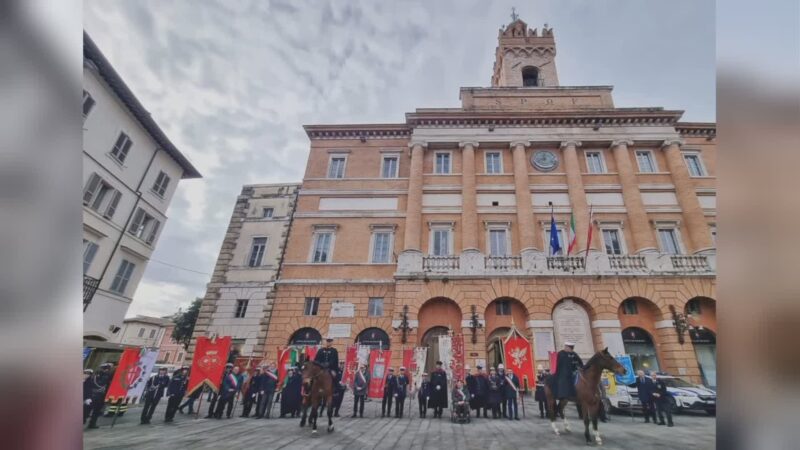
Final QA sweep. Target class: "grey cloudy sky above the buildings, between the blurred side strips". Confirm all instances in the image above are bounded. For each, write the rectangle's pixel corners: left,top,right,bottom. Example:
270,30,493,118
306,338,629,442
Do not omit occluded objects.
84,0,715,316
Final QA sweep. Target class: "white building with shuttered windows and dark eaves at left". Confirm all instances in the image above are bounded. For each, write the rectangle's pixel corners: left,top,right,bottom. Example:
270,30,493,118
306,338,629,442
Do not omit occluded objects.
83,33,200,341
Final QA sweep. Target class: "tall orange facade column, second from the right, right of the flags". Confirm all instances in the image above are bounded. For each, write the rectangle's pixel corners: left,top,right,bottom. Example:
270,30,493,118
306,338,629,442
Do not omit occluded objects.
611,140,658,253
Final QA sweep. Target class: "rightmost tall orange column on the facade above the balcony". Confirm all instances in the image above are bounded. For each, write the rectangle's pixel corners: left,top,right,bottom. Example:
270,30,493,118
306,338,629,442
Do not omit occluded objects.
661,139,714,253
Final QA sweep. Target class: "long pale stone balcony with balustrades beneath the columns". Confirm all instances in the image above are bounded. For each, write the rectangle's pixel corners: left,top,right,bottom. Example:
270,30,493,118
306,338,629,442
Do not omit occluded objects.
395,249,716,277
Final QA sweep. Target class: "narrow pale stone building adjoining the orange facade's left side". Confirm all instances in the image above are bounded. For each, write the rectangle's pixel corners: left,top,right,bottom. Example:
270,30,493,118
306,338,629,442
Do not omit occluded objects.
187,184,299,359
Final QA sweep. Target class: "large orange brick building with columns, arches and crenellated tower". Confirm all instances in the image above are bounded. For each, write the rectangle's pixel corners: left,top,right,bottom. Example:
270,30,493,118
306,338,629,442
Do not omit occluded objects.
264,20,716,385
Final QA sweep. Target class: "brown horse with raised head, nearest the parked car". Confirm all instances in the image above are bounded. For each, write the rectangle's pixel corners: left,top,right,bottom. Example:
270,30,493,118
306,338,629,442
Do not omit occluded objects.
544,347,626,445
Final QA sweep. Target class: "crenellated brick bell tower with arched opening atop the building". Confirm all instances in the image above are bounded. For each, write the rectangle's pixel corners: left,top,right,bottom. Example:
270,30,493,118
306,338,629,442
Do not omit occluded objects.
492,13,558,87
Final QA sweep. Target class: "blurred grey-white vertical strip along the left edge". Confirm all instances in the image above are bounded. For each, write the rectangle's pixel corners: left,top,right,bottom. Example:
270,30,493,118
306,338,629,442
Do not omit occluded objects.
0,0,82,449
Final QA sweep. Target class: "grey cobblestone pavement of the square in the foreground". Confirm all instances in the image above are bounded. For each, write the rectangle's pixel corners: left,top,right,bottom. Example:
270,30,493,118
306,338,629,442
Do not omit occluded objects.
83,393,716,450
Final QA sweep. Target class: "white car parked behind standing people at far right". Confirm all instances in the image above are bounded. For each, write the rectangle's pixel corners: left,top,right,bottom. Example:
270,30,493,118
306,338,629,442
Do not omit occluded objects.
608,375,717,416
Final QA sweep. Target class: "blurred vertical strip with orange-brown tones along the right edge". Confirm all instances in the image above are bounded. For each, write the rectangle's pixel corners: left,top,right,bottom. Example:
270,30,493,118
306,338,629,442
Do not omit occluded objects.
717,0,800,449
